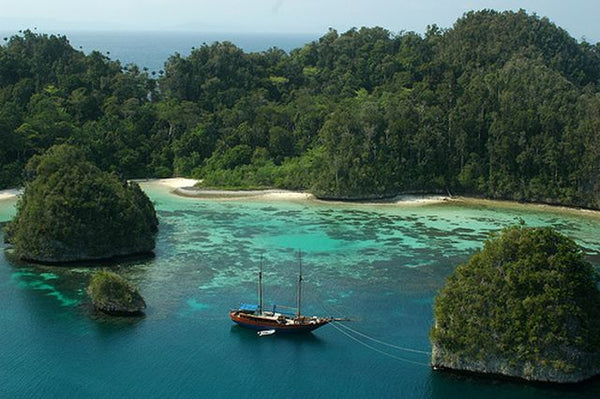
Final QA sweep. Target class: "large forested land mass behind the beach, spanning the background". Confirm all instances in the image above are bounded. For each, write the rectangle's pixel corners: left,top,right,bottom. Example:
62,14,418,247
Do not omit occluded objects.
0,10,600,209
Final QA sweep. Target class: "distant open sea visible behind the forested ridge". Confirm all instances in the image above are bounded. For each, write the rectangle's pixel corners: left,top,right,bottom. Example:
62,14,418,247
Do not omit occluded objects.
0,31,320,73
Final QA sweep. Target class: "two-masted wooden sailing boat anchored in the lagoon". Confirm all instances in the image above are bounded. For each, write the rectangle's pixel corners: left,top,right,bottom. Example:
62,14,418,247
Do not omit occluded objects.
229,253,343,333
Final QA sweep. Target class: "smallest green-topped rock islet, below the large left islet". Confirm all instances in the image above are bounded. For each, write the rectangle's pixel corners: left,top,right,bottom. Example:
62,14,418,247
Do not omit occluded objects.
87,270,146,316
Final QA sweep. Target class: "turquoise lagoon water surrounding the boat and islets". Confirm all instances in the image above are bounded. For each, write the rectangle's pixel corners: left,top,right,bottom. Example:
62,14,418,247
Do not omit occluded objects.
0,188,600,398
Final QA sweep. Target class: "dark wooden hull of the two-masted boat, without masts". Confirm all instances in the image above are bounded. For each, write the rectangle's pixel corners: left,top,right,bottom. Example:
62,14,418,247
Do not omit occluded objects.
229,310,332,333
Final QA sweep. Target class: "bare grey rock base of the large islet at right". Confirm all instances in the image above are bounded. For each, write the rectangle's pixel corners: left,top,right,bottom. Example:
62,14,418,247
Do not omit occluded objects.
431,344,600,384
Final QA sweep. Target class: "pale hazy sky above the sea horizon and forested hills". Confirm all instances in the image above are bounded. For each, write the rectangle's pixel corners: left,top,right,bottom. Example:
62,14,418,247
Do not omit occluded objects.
0,0,600,44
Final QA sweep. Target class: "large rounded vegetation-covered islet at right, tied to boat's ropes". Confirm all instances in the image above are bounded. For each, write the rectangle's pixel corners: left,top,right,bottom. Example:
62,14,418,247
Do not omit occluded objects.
431,225,600,383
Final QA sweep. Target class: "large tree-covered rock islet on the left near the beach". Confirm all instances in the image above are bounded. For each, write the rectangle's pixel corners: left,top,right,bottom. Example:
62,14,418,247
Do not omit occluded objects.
6,145,158,263
